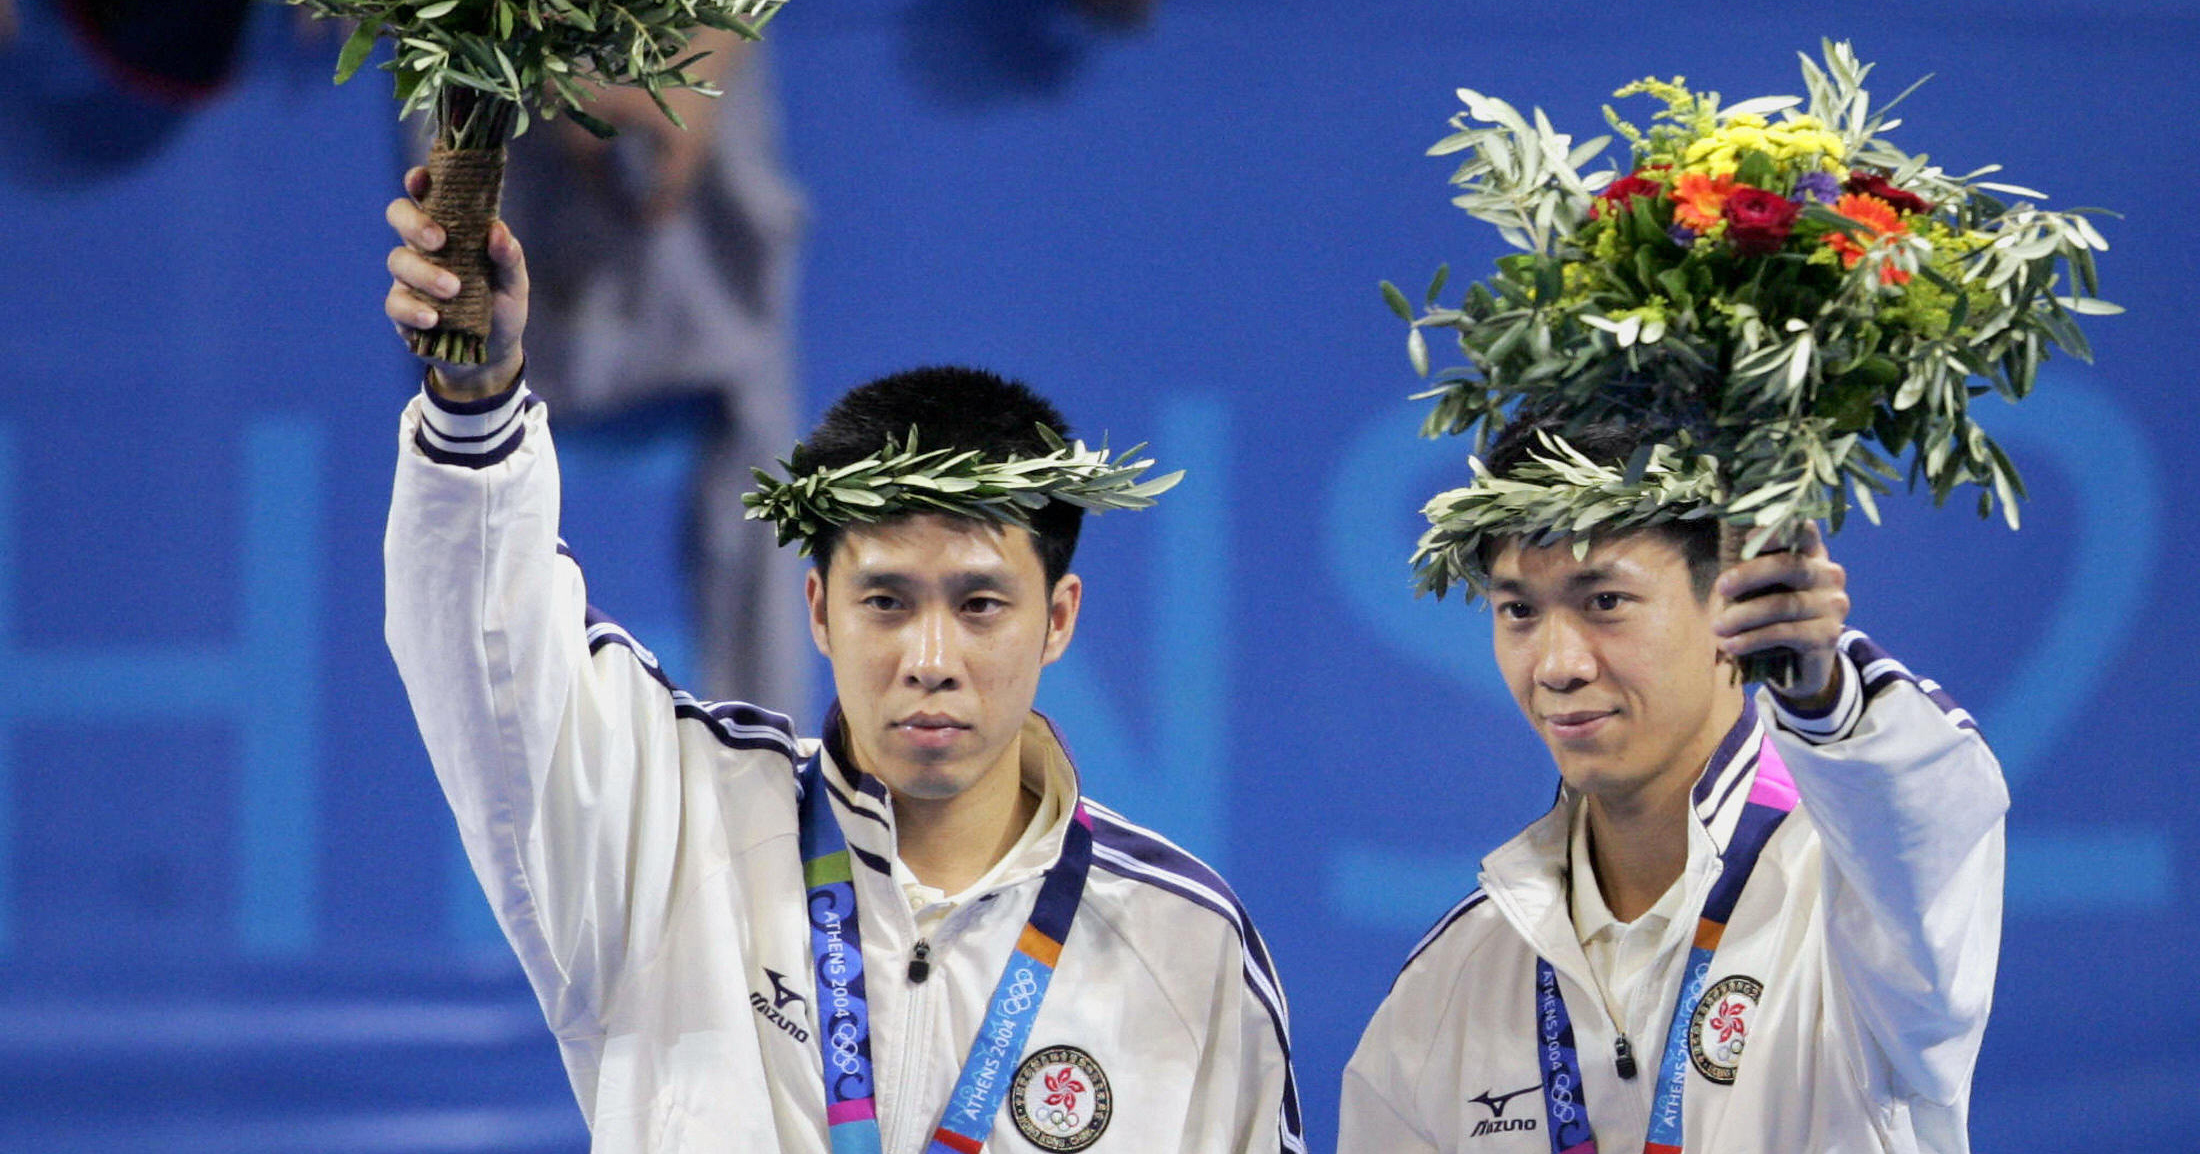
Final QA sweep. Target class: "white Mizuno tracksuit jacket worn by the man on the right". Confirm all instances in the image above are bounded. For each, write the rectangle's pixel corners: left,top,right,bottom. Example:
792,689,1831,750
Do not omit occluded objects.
1338,633,2009,1154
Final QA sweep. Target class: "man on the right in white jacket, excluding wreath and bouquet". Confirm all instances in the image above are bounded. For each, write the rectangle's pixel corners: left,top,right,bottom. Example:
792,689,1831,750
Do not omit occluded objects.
1340,420,2009,1154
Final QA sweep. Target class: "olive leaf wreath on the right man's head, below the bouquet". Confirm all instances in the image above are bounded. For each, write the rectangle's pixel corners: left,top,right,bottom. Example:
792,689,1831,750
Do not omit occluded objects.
1412,431,1727,598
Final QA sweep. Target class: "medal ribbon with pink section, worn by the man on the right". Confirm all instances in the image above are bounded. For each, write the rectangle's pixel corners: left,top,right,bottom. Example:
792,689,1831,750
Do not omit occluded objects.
1536,734,1795,1154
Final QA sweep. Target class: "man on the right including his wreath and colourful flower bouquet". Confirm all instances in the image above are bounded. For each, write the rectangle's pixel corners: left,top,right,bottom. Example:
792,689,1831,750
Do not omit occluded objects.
1340,42,2059,1154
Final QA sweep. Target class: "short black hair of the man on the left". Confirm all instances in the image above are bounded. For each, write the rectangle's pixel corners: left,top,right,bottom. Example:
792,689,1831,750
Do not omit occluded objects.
788,365,1085,591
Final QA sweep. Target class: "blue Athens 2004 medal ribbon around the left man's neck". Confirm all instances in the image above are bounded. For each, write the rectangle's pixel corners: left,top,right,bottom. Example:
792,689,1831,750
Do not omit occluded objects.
801,754,1093,1154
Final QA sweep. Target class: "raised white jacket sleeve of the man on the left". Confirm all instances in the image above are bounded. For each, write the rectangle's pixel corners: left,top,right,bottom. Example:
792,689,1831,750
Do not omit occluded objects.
383,385,774,1038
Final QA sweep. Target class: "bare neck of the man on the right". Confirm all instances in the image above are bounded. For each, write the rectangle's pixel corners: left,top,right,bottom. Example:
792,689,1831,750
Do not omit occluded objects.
1582,699,1742,923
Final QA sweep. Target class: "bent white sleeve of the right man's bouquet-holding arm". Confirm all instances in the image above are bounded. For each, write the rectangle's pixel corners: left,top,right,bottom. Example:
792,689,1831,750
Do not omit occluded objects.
1767,631,2009,1103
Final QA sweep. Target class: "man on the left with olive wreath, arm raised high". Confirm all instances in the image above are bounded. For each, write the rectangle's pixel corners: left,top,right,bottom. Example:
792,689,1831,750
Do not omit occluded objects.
385,169,1305,1154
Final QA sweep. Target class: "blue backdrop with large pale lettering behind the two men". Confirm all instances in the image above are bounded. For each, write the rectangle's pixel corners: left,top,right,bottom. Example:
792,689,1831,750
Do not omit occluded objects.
0,0,2200,1152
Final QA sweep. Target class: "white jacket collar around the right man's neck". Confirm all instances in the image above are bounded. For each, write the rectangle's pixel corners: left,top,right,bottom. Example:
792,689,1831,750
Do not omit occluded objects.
1481,695,1764,969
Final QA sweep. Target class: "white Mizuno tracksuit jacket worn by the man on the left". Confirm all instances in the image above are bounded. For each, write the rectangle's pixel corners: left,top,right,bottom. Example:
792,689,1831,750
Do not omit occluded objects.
385,387,1305,1154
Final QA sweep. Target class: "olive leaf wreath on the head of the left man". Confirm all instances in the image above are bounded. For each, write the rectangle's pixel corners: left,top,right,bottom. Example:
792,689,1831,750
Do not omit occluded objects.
741,424,1184,554
